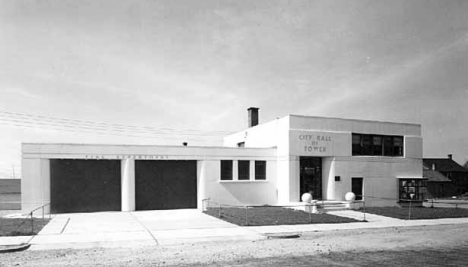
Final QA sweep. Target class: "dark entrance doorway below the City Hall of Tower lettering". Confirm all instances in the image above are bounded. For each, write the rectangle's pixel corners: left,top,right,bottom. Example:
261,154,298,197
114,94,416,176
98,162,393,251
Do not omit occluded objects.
299,157,322,201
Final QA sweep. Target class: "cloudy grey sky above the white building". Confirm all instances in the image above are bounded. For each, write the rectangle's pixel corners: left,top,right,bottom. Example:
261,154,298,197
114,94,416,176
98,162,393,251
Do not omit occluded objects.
0,0,468,177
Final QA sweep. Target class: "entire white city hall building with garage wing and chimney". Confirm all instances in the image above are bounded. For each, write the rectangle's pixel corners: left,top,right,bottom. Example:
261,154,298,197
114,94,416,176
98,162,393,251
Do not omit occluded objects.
21,108,425,213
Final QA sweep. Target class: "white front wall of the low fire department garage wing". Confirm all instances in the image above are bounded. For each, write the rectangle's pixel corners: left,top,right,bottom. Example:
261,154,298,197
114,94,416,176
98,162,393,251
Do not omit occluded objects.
21,144,278,211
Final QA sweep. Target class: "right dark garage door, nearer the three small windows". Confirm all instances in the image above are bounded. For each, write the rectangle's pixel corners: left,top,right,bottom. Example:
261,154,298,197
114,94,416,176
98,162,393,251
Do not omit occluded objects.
135,160,197,210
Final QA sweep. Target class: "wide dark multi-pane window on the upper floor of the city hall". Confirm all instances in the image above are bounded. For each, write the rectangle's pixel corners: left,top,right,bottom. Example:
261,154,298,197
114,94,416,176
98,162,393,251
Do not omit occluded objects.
352,133,403,157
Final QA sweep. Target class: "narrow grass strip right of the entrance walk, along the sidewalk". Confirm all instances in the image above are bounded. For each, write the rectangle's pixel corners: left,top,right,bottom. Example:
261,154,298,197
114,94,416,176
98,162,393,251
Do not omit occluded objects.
360,207,468,220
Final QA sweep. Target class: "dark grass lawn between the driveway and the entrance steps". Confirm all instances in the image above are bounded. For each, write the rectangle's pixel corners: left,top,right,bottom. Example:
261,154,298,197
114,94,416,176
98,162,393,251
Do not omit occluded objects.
205,206,359,226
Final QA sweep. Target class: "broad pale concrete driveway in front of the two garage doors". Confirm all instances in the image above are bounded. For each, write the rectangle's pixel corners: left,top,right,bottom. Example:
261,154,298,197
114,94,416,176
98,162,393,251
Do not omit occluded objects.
30,209,261,249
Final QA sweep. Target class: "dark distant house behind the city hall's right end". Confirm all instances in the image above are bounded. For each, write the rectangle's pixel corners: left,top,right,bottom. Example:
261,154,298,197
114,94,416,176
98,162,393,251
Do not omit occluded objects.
423,154,468,197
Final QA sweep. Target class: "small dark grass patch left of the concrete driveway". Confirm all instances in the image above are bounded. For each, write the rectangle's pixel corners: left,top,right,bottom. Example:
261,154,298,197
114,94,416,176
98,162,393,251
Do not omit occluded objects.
0,218,50,236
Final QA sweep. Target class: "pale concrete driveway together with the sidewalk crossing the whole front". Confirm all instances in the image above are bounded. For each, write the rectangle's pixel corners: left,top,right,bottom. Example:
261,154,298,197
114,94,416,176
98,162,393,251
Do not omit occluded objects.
0,209,468,250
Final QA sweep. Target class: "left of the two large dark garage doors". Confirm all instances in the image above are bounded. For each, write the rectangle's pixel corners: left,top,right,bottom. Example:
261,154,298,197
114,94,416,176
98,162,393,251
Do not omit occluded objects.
50,159,121,213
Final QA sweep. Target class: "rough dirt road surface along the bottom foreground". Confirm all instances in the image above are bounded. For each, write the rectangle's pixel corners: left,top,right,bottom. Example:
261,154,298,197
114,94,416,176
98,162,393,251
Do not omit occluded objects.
0,224,468,266
